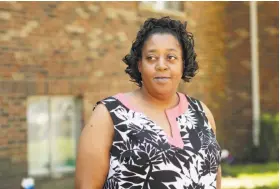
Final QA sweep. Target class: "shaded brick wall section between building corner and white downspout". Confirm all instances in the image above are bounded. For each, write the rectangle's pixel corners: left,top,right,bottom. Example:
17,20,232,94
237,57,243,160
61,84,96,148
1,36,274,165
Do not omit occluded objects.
221,2,252,159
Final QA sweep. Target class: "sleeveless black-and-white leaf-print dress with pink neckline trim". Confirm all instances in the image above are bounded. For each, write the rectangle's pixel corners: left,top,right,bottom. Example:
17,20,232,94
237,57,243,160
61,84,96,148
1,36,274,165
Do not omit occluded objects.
96,93,221,189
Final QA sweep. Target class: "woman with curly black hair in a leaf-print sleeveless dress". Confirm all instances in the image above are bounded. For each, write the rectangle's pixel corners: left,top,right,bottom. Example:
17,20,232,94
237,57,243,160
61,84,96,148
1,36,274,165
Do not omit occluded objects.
76,17,221,189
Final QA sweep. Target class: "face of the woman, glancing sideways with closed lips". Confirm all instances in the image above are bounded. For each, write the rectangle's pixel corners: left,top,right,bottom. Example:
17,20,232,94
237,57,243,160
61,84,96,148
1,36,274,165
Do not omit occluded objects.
138,33,183,96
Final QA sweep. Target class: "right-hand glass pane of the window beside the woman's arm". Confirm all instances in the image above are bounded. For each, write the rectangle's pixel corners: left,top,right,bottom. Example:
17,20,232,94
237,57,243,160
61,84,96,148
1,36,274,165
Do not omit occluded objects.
51,96,82,172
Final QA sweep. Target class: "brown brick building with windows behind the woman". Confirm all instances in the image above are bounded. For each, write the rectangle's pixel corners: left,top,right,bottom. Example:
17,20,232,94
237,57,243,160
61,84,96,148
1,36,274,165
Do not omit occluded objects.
0,2,279,189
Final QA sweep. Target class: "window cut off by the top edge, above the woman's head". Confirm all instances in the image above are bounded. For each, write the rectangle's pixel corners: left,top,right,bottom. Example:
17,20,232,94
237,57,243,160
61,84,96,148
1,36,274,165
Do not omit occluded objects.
141,1,183,12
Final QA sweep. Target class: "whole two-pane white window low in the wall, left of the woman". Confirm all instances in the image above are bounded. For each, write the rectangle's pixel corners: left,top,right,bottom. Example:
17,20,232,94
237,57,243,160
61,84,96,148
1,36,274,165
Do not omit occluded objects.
27,96,82,175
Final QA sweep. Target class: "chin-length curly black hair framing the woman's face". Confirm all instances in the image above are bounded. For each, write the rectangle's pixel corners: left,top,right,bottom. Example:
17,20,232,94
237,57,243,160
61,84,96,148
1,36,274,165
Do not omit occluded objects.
123,16,198,87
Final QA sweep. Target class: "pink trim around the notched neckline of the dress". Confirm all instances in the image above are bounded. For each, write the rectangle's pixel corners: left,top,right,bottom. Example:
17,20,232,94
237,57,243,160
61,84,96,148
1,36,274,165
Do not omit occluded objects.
114,93,188,148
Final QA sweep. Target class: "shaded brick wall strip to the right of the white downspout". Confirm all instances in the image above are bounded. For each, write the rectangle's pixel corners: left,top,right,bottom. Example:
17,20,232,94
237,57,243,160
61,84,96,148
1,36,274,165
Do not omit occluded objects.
258,2,279,114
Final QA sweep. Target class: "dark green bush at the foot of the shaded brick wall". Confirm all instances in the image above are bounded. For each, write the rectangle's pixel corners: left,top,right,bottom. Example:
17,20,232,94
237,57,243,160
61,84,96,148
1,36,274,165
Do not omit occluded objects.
251,114,279,163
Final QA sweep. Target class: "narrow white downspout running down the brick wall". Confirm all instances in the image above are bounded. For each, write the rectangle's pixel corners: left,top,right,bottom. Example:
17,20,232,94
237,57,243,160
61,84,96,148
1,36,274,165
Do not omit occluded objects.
250,1,260,146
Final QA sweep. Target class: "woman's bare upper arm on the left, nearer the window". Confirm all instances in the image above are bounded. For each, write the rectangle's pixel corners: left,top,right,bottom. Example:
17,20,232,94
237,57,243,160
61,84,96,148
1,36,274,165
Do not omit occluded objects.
75,104,114,189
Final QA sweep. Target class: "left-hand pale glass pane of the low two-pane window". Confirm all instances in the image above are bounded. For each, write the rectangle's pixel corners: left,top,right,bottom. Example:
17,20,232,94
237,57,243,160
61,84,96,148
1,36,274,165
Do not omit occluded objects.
27,97,50,175
